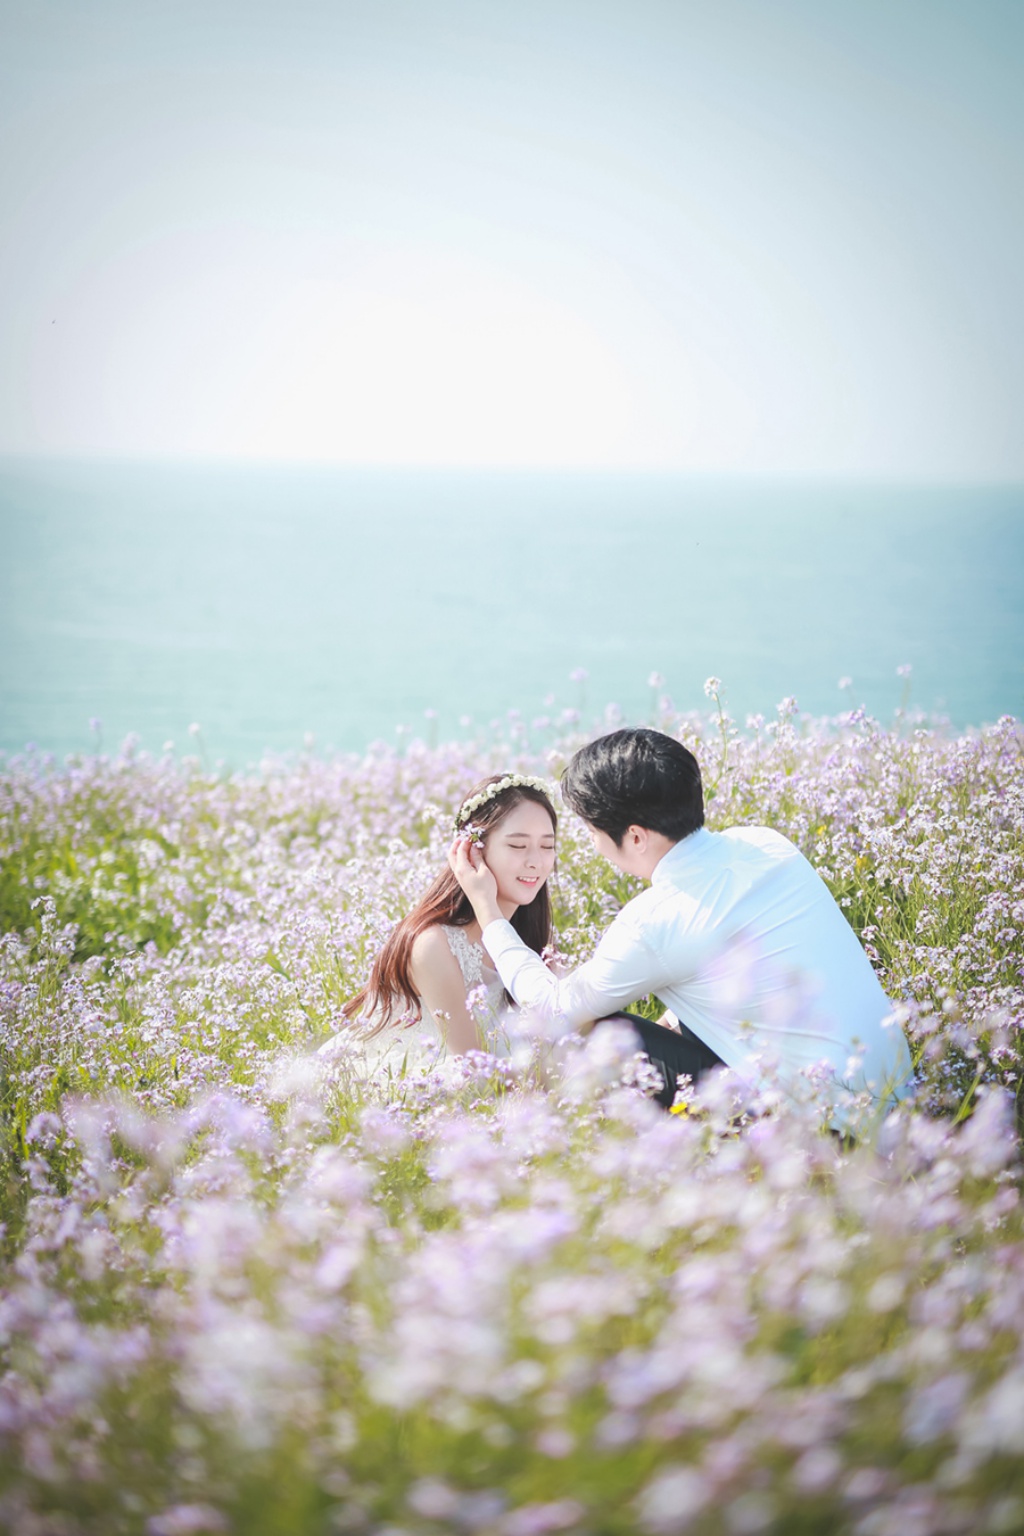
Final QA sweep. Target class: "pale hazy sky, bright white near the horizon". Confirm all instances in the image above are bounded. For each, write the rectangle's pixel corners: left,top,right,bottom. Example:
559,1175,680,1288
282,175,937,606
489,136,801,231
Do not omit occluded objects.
0,0,1024,479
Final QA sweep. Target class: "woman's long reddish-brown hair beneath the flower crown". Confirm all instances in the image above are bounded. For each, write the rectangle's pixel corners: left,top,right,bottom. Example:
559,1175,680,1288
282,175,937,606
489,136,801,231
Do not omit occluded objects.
342,774,559,1035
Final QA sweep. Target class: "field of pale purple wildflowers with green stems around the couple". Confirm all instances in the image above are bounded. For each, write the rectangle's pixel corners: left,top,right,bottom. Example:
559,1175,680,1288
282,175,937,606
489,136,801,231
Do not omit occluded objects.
0,690,1024,1536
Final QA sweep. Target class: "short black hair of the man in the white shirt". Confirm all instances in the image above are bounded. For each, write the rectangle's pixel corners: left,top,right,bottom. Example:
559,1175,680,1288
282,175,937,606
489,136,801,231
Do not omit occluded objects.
560,727,705,848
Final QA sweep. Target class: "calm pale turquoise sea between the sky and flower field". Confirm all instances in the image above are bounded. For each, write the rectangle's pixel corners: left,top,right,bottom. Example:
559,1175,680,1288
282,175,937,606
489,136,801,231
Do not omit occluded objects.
0,461,1024,766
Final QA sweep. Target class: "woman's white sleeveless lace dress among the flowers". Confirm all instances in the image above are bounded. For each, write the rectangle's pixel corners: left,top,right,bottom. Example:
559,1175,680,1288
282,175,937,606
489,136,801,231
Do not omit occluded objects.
316,923,511,1077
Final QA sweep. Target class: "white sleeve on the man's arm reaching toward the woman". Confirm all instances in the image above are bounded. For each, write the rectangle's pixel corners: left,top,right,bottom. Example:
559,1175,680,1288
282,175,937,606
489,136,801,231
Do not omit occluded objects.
484,915,666,1031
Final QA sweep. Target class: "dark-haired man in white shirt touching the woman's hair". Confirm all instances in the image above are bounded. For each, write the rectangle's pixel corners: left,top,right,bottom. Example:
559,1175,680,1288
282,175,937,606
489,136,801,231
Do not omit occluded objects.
451,730,910,1103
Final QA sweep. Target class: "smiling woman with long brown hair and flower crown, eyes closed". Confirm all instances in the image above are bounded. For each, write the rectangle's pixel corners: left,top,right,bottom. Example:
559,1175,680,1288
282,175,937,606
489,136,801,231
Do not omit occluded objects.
342,774,557,1055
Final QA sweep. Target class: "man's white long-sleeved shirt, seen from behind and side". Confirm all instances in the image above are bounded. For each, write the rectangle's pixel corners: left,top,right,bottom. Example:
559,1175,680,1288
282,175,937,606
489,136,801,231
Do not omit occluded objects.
484,826,910,1097
